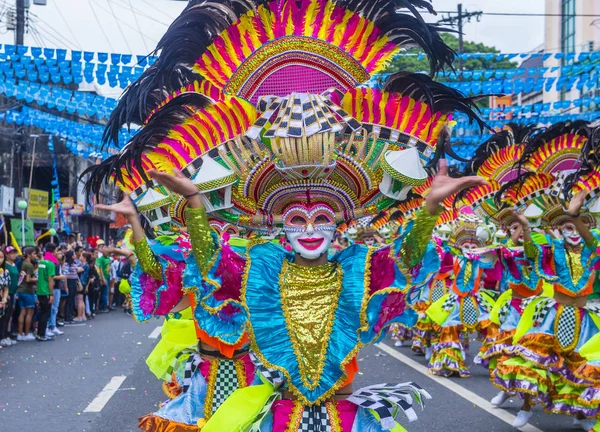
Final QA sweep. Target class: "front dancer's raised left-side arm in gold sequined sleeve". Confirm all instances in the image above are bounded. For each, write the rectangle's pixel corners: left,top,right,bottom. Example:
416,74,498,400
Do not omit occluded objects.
148,170,216,273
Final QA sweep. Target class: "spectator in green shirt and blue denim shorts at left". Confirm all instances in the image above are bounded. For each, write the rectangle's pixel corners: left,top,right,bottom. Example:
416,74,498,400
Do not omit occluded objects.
17,246,37,341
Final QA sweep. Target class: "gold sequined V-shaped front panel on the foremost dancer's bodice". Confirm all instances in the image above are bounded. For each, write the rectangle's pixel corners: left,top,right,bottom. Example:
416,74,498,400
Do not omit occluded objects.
279,261,342,389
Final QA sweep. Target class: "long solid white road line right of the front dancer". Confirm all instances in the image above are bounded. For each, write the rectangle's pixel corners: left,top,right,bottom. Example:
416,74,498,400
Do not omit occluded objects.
375,343,543,432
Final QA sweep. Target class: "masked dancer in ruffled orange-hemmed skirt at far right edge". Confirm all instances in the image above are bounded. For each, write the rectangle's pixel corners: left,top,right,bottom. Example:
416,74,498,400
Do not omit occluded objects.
495,122,600,430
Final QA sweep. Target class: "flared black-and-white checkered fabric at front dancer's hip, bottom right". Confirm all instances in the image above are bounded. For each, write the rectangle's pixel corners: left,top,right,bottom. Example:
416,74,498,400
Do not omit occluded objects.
348,382,431,430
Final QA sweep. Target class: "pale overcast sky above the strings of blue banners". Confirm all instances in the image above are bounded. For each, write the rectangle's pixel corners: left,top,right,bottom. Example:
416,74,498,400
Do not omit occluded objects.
0,0,544,54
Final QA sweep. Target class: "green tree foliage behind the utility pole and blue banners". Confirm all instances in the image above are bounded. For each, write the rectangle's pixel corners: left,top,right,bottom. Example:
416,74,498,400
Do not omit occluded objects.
385,33,517,76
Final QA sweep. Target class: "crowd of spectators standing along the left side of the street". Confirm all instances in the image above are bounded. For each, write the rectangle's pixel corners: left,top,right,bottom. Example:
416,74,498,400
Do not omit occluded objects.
0,240,135,349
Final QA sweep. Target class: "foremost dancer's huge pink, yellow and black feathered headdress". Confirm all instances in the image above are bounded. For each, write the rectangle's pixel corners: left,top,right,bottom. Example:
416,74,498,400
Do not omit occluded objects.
88,0,479,227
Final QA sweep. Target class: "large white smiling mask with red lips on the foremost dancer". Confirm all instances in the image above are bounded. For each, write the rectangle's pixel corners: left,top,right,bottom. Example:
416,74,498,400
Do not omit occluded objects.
283,205,336,260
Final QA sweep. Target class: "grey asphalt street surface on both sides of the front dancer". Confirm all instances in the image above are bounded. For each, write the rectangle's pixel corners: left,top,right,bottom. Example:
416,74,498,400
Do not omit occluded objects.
0,311,575,432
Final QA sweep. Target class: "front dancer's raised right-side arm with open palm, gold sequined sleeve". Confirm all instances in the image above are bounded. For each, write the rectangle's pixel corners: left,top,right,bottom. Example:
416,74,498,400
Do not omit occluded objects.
400,159,485,268
